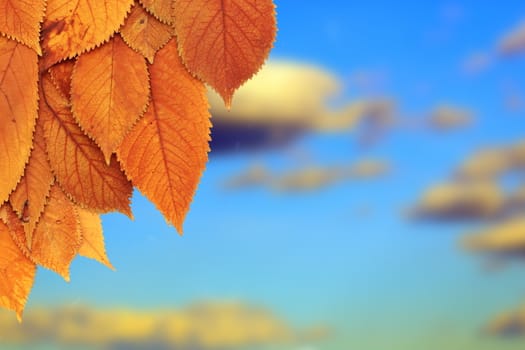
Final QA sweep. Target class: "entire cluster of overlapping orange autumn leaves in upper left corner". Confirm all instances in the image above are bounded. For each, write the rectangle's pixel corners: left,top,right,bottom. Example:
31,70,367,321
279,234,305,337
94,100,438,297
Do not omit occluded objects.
0,0,276,317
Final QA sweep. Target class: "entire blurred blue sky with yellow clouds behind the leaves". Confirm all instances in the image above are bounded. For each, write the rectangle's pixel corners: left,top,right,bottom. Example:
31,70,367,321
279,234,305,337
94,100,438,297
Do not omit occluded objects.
0,0,525,350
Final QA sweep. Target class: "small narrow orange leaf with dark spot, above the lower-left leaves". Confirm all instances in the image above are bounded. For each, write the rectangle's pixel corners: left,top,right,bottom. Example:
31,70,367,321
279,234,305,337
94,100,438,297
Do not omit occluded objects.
9,122,54,247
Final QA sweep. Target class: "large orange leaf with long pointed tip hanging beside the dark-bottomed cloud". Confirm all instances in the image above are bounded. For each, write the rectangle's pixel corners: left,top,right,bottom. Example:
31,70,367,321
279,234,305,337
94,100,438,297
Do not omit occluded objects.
117,39,210,233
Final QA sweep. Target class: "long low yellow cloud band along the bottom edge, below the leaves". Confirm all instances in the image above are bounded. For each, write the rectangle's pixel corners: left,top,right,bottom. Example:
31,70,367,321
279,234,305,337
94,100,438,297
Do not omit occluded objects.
0,303,330,350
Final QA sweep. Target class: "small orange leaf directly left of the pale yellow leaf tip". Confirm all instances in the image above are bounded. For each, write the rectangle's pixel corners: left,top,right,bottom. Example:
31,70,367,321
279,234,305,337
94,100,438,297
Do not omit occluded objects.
28,184,82,281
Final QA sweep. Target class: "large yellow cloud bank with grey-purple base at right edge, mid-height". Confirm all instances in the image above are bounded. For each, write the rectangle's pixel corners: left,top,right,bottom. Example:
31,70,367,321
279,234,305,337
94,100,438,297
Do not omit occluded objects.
410,141,525,222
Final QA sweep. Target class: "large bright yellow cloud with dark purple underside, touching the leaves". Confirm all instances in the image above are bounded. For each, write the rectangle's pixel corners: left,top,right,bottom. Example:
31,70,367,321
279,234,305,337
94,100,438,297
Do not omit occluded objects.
208,61,394,151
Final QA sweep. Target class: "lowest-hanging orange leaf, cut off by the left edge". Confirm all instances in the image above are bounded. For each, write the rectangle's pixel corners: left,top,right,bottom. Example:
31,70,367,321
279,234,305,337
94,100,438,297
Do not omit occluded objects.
0,220,36,320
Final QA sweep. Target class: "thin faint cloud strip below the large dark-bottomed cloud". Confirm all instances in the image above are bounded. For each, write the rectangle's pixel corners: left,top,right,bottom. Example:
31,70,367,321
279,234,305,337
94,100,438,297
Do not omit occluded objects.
224,159,391,192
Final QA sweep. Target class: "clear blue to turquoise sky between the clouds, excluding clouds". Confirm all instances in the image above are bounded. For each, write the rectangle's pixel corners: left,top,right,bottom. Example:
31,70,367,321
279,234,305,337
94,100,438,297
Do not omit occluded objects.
3,0,525,350
